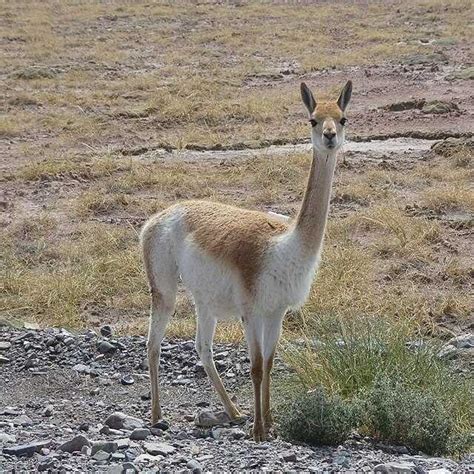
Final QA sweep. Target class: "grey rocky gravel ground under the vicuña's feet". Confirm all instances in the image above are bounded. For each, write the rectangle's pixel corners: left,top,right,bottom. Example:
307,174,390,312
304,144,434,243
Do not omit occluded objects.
0,326,474,474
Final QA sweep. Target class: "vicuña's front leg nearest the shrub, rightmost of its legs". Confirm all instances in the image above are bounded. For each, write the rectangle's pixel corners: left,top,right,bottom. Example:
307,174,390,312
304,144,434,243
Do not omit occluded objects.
262,312,284,434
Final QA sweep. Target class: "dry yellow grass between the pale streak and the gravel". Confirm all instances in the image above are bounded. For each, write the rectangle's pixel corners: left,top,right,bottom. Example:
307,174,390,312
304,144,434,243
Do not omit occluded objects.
3,140,472,340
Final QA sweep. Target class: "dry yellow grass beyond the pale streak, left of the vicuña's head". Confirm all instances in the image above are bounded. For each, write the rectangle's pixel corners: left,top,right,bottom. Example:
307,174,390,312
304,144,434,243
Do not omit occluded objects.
0,0,469,153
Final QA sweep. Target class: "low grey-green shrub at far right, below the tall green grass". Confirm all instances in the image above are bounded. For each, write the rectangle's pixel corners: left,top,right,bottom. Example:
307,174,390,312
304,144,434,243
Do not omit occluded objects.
366,377,470,454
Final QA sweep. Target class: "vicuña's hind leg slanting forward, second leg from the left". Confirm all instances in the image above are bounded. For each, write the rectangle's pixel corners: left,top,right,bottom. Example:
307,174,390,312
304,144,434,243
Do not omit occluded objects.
196,309,242,420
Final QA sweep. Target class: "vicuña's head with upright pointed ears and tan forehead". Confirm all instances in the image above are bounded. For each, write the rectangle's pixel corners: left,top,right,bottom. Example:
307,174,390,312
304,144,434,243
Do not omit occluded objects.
301,81,352,153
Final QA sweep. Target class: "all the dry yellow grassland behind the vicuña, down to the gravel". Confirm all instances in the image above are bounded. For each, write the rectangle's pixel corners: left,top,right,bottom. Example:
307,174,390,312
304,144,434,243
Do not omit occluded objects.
0,0,474,339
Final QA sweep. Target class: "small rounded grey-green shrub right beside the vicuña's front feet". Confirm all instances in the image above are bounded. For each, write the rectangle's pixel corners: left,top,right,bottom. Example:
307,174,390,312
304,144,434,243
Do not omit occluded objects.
279,388,360,445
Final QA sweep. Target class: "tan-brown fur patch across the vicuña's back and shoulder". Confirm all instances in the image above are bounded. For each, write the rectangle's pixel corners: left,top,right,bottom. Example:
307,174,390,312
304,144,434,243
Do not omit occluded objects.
178,201,288,292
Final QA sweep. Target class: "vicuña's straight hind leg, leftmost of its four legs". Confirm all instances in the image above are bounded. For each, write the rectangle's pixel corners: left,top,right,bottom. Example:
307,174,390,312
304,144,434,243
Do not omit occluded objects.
148,290,175,423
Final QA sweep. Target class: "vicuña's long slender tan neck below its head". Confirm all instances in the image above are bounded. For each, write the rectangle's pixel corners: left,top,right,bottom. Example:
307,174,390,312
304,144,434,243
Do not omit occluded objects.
293,148,336,254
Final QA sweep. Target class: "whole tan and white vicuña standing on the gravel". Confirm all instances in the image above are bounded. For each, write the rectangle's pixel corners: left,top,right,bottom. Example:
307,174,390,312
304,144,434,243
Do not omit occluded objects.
141,82,352,441
